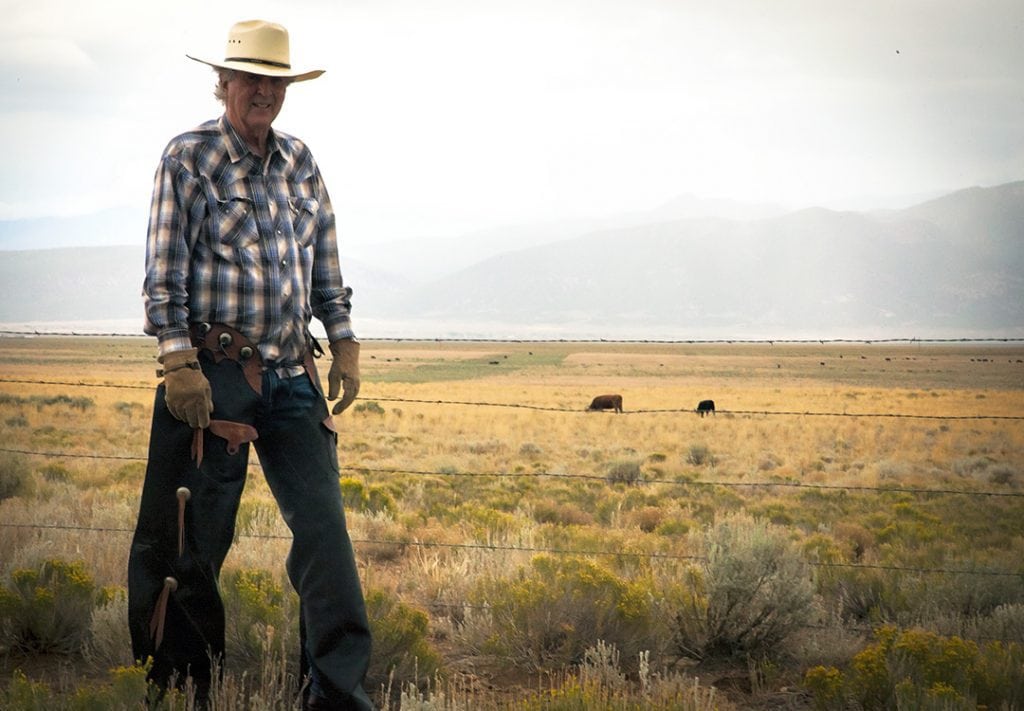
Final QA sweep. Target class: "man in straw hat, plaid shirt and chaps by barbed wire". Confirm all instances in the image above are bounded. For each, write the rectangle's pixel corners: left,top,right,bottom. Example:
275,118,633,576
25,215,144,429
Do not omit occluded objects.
128,20,373,710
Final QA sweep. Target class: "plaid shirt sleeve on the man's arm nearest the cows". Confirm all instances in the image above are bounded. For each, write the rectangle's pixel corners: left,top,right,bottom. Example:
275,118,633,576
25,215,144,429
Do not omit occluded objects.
309,169,355,343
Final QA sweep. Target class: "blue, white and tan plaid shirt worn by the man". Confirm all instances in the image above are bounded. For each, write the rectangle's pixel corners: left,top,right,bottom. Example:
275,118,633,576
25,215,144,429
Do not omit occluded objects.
142,116,353,364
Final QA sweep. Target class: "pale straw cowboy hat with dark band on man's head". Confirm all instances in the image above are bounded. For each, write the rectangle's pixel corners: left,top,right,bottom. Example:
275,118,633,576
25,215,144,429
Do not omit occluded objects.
185,19,324,82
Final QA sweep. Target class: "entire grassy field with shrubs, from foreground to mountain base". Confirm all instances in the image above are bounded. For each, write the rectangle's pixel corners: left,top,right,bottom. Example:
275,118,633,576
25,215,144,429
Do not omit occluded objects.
0,337,1024,710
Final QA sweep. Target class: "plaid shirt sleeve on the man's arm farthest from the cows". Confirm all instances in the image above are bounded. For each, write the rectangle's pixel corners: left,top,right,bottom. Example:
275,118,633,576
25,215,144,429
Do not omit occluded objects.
142,155,206,356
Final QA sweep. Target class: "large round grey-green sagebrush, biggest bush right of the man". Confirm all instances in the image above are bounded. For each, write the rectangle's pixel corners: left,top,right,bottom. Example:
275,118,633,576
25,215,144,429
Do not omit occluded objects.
679,514,814,659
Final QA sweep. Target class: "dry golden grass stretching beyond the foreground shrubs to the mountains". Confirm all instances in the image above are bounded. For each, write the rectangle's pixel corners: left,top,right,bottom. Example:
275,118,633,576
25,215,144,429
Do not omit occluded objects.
0,338,1024,708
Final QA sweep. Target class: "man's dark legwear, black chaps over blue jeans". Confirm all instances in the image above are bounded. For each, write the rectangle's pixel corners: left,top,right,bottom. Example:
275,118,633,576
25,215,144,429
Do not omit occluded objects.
128,353,373,711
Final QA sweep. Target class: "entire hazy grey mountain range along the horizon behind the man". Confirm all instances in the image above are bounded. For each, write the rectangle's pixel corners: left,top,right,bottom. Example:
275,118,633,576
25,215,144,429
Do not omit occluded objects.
0,181,1024,339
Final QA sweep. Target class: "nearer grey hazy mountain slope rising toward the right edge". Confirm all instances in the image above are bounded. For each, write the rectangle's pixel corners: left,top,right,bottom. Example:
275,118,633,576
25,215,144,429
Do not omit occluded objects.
378,182,1024,337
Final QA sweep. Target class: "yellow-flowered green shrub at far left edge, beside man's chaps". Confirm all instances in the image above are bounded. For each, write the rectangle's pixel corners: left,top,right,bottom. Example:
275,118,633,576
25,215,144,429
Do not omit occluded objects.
0,559,105,654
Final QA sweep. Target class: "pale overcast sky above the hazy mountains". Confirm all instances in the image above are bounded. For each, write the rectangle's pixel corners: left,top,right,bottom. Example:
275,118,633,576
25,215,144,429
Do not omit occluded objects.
0,0,1024,243
